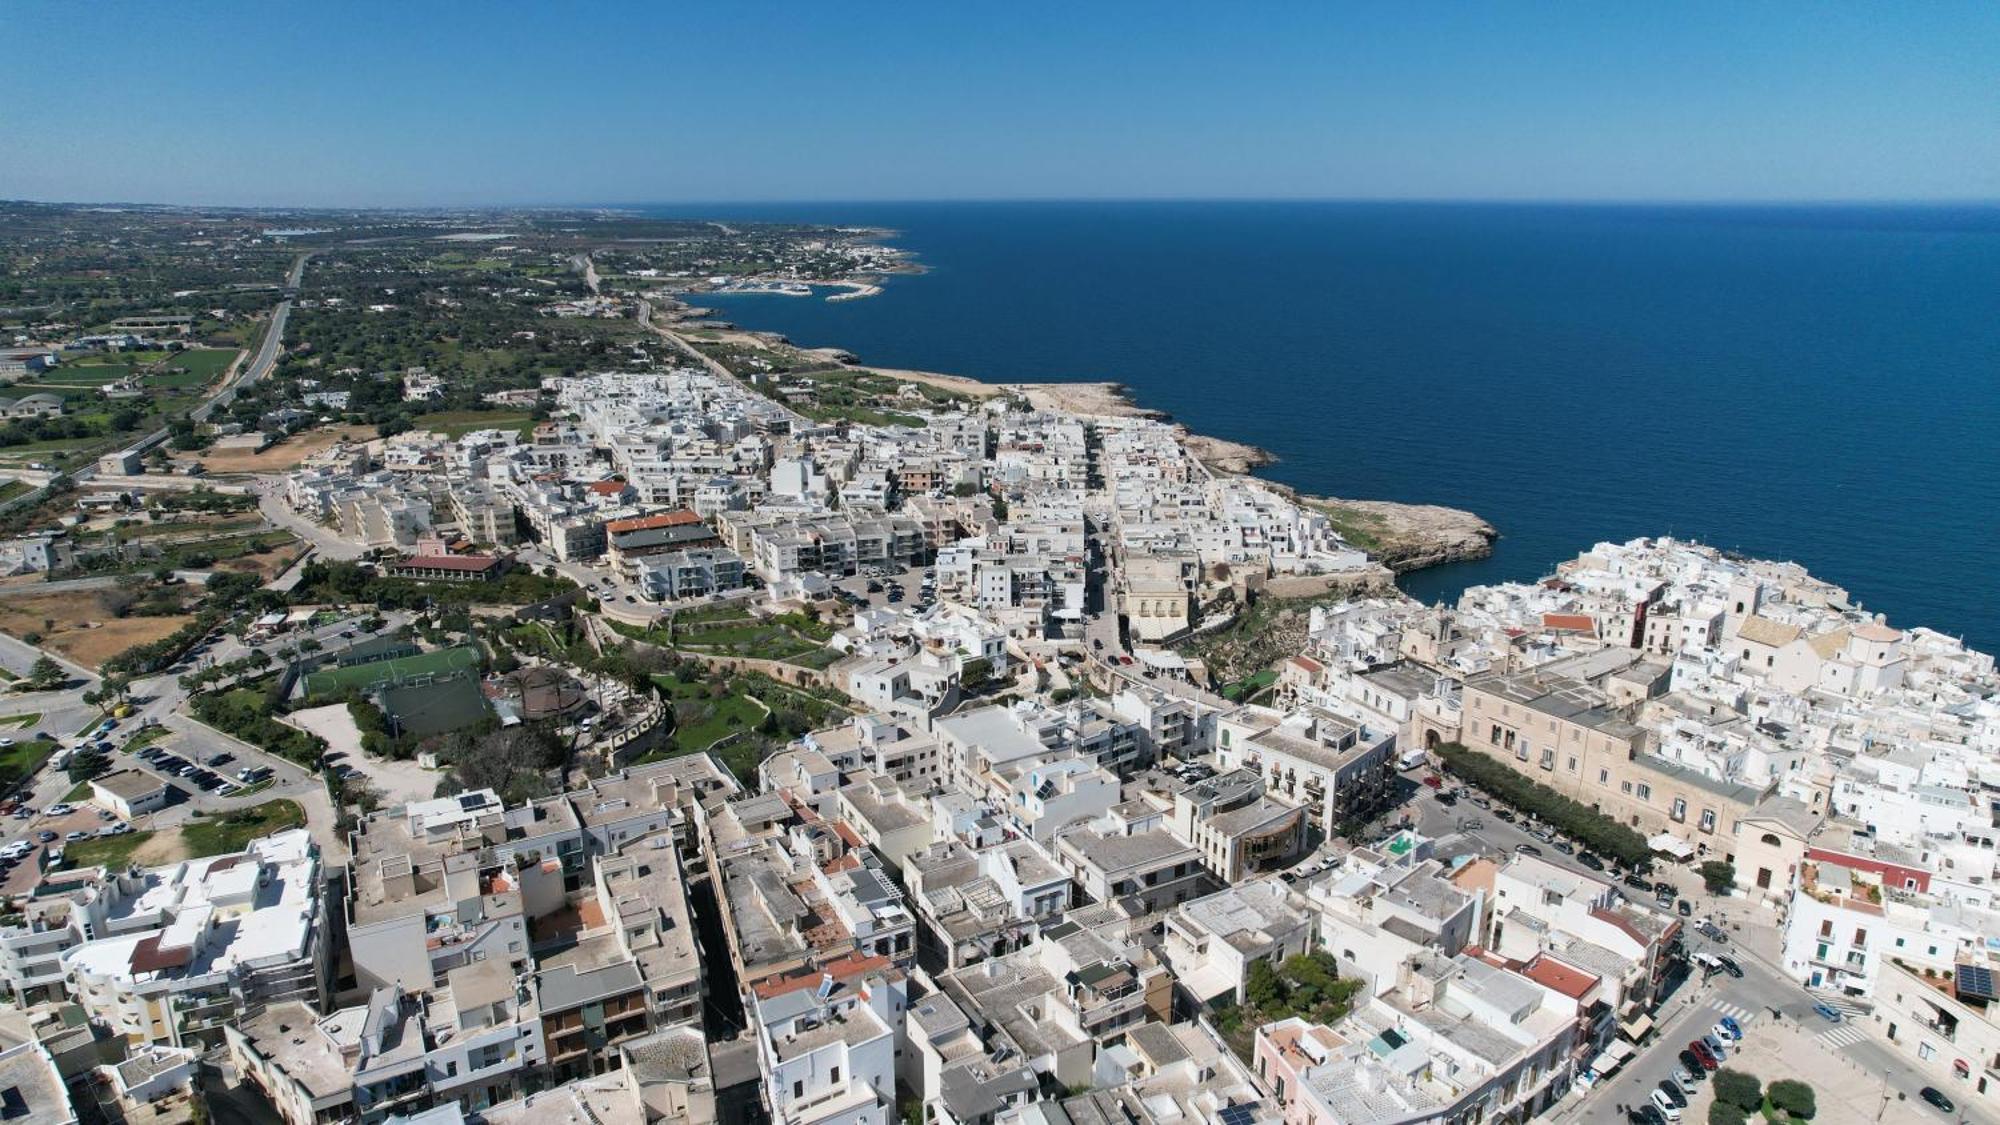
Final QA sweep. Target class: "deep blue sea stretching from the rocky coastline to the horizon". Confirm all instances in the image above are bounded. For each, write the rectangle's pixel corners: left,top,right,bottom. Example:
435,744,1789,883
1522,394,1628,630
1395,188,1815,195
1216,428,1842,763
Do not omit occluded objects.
650,202,2000,651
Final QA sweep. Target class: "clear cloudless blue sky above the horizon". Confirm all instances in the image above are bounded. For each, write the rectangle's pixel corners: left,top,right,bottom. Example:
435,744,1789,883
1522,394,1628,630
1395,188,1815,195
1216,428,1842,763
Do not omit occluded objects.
0,0,2000,206
